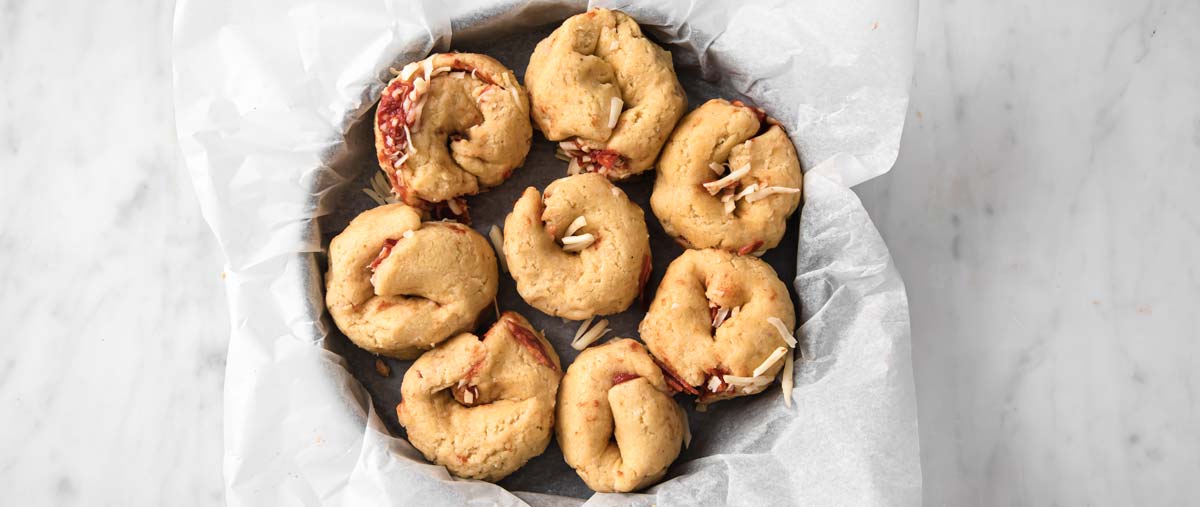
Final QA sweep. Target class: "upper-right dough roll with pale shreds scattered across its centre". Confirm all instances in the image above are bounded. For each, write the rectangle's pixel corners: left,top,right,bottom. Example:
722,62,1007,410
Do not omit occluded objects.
650,99,803,255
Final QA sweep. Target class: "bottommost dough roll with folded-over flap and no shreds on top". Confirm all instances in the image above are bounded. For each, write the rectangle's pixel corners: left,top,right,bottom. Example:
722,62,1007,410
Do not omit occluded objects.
557,338,688,493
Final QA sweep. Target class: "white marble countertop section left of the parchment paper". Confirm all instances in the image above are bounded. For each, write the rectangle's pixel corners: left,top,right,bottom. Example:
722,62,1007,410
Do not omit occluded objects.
0,1,228,506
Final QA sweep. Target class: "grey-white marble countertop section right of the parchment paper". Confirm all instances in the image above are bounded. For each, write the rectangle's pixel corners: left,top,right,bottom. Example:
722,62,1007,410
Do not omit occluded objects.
857,0,1200,506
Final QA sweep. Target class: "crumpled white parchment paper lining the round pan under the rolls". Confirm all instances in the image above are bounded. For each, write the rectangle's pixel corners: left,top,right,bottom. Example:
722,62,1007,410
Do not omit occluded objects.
174,0,920,506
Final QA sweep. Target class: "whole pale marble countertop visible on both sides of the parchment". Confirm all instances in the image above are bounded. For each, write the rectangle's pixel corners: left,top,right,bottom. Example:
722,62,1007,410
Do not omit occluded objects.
0,0,1200,505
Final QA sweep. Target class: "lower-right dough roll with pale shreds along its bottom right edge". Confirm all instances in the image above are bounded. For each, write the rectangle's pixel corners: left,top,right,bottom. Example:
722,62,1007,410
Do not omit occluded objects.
638,250,797,404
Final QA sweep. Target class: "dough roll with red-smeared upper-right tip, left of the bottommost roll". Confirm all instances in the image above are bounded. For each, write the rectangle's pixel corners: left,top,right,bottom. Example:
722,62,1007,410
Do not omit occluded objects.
396,311,563,482
